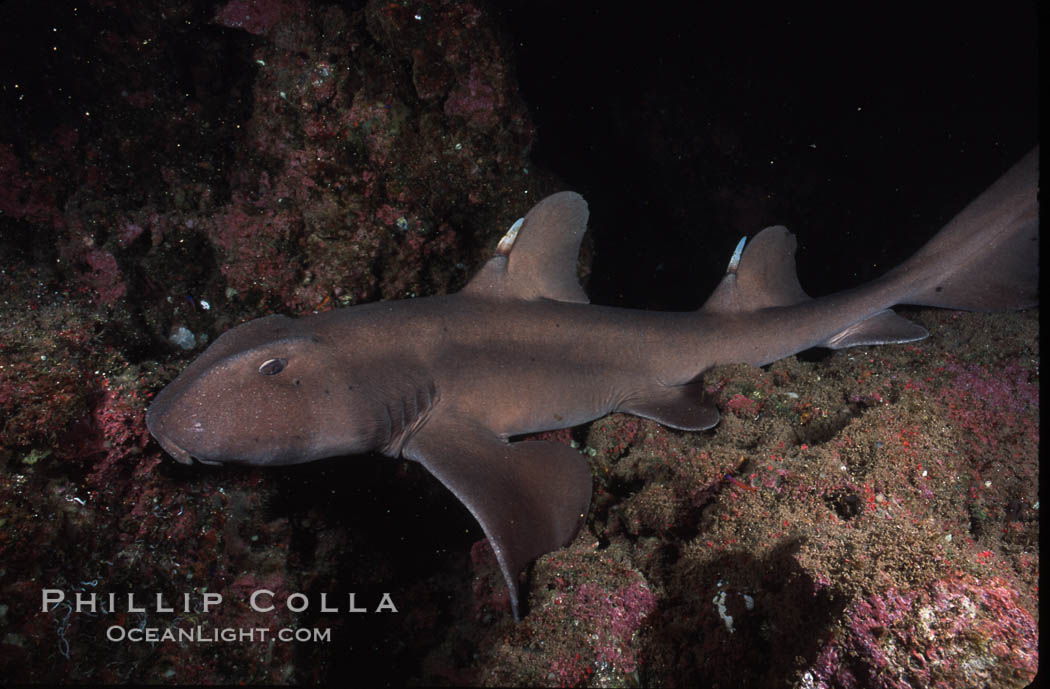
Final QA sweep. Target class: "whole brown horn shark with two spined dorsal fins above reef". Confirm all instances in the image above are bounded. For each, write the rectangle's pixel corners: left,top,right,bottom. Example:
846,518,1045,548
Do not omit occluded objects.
146,148,1038,620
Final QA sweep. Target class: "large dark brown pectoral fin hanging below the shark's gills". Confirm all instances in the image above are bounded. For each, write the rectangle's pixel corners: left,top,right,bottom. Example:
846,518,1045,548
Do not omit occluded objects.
402,418,591,620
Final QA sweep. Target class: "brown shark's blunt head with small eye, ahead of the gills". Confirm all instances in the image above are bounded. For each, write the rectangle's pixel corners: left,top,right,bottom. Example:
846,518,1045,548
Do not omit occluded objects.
146,316,385,464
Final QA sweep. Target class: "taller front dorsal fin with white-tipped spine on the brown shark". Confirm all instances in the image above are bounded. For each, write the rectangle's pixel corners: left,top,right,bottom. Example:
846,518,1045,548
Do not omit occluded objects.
463,191,588,304
